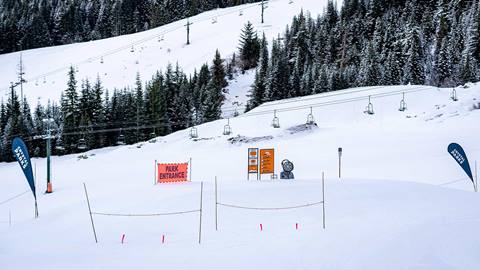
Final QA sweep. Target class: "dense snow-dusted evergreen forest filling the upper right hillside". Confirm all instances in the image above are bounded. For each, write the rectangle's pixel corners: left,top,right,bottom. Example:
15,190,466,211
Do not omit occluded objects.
247,0,480,110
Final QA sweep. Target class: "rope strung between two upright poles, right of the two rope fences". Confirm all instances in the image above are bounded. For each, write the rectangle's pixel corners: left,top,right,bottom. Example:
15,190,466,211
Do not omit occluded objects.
215,172,325,231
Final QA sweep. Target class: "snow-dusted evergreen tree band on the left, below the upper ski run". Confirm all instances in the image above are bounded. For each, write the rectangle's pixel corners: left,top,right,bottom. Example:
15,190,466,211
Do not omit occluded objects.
0,48,232,161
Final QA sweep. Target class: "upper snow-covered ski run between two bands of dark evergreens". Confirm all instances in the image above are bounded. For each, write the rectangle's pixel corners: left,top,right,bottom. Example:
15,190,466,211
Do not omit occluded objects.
0,0,327,106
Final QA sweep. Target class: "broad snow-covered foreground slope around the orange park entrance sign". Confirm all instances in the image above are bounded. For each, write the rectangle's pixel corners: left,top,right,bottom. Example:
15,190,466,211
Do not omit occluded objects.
0,83,480,269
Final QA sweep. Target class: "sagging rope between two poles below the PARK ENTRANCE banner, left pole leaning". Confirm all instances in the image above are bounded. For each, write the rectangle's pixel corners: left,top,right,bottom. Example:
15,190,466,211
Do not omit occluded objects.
83,182,203,244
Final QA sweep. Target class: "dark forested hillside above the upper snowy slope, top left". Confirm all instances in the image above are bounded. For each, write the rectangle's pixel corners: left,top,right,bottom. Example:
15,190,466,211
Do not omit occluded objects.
0,0,258,54
